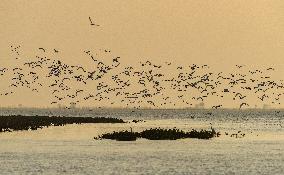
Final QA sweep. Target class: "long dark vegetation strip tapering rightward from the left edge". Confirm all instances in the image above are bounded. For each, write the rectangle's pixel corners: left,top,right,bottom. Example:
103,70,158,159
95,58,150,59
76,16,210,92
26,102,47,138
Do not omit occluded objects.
0,115,125,132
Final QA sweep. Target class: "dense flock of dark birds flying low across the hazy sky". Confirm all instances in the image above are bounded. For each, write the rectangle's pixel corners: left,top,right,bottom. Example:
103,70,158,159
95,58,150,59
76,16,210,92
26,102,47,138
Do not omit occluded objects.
0,43,284,109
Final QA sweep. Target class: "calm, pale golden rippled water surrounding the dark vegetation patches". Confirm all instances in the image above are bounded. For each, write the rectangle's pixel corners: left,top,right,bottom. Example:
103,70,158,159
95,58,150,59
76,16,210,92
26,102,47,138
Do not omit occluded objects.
0,109,284,174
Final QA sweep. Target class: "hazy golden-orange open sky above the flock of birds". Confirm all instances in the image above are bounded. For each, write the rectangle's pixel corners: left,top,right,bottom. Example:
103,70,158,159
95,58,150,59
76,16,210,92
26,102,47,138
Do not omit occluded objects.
0,0,284,106
